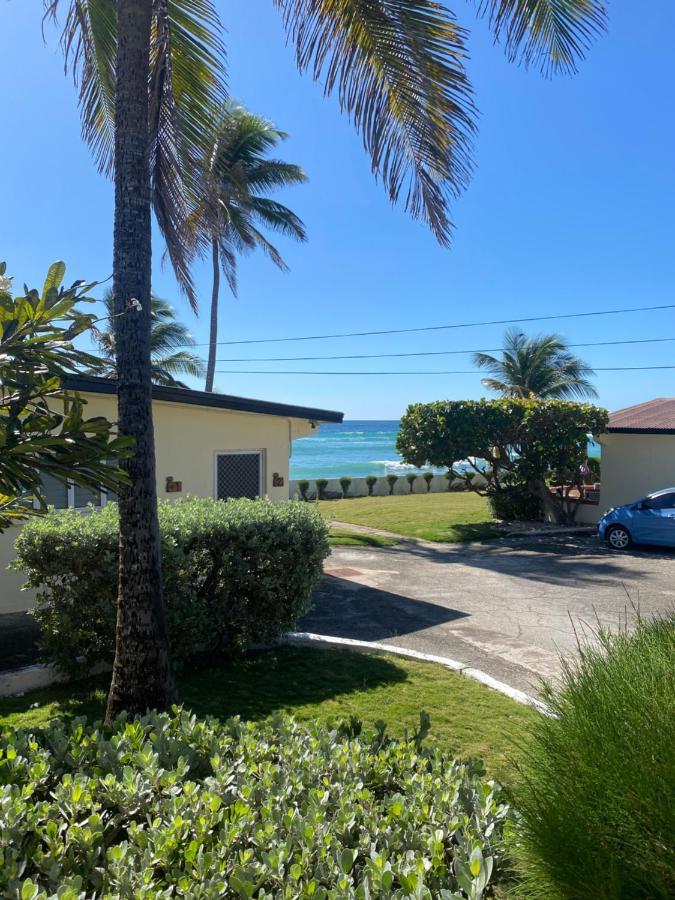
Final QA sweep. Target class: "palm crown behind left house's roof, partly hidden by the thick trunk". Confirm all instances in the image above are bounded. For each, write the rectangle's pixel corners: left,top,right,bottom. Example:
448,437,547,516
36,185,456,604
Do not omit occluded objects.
94,291,206,387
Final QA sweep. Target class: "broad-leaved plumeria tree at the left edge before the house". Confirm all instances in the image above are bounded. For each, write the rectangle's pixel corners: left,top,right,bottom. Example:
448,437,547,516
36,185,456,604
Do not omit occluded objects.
0,262,132,531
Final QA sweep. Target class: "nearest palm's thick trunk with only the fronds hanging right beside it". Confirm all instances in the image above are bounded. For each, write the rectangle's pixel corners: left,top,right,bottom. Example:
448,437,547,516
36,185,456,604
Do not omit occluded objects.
44,0,230,721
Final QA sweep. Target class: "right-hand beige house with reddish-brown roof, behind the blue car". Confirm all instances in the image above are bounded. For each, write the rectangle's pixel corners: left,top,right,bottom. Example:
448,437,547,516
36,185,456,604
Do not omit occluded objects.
596,397,675,515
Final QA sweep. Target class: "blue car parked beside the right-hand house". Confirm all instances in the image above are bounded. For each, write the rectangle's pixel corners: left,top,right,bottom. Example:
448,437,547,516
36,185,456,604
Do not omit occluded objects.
598,487,675,550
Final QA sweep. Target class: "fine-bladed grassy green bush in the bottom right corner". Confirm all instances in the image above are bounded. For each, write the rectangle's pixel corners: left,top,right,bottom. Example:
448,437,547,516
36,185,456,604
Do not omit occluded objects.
515,615,675,900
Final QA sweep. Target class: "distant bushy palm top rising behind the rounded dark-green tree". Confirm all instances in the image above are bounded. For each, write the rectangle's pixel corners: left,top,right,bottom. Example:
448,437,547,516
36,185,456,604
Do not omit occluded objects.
473,328,598,400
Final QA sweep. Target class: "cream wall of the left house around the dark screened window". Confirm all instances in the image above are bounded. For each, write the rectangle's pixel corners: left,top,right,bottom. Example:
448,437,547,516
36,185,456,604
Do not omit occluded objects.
0,394,312,614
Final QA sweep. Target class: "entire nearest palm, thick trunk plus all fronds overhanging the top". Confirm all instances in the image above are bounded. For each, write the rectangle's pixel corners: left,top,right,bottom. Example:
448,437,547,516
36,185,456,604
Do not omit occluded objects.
45,0,605,718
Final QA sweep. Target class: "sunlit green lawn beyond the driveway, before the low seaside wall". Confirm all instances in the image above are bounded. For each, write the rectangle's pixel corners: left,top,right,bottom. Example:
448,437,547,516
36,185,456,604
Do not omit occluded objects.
319,491,501,542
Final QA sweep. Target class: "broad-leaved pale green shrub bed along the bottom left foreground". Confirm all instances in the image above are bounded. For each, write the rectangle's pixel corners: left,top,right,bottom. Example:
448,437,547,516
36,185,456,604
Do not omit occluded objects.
0,710,507,900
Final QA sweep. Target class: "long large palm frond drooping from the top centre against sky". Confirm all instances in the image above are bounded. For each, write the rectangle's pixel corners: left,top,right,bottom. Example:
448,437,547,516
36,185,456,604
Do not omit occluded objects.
274,0,475,245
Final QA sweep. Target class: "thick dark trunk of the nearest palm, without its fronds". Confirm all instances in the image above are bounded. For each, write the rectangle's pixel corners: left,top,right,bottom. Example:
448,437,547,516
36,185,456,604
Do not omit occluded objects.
106,0,173,721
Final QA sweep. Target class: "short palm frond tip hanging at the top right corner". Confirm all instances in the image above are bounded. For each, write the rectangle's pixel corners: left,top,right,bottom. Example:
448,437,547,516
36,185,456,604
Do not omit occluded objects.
478,0,606,75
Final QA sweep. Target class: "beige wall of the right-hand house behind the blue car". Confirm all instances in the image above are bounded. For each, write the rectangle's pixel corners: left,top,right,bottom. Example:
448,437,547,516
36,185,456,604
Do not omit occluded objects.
598,434,675,514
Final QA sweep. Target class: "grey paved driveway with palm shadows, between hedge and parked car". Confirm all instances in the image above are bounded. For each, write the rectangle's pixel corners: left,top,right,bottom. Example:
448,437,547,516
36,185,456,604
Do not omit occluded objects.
300,536,675,692
